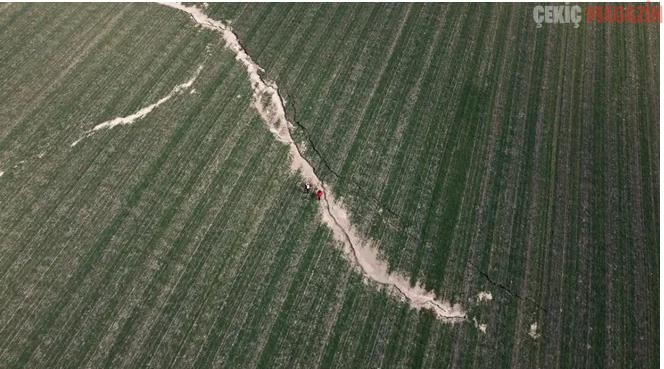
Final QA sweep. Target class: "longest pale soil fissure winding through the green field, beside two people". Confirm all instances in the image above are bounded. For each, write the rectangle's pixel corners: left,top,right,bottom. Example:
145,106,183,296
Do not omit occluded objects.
163,3,466,322
